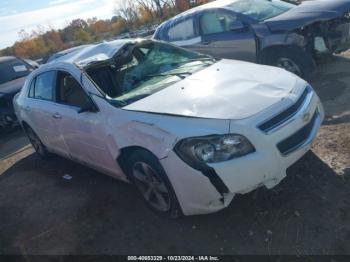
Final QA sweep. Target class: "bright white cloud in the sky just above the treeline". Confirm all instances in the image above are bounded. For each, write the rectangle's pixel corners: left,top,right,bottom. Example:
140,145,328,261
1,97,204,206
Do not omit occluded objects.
0,0,115,49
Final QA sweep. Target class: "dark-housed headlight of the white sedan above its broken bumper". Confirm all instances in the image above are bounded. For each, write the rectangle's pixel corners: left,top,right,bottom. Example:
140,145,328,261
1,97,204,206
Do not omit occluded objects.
175,134,255,167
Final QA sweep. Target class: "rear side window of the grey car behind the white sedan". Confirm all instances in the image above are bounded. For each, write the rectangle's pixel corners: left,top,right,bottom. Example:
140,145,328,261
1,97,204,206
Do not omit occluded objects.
168,19,196,42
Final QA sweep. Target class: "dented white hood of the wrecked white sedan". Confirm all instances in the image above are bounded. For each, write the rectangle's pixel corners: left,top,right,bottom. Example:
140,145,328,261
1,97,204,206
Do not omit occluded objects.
123,60,303,119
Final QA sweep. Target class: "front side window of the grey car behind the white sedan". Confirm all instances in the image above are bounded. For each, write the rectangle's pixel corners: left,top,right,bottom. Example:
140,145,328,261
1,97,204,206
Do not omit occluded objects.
200,12,237,35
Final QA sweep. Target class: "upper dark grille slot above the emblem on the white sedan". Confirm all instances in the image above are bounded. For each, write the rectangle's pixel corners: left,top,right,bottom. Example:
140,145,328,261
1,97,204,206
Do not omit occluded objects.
258,87,311,133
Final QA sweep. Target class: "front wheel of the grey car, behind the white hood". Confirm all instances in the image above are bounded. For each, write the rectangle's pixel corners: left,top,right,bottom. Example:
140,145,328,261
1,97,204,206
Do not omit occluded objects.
260,46,316,80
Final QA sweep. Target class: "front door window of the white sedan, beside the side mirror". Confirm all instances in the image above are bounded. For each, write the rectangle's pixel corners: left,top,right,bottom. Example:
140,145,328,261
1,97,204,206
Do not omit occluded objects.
56,72,91,108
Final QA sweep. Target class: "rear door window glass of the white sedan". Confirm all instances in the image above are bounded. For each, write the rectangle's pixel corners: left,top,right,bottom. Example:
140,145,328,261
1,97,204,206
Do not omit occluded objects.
34,71,55,101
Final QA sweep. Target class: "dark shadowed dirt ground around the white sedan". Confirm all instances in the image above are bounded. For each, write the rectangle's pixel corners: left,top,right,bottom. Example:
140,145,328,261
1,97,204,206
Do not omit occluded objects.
0,53,350,255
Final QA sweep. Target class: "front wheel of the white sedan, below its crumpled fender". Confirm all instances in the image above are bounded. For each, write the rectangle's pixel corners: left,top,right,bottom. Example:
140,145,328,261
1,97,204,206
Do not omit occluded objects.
127,150,182,219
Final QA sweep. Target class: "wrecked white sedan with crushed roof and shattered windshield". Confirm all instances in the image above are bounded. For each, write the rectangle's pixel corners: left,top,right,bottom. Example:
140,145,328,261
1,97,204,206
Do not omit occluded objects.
14,40,324,217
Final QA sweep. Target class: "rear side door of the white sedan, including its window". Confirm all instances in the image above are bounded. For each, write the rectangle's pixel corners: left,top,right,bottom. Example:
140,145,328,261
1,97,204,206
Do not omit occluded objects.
24,71,68,156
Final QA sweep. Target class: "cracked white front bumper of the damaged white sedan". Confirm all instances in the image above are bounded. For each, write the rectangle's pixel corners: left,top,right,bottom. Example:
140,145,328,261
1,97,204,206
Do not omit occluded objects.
161,89,324,215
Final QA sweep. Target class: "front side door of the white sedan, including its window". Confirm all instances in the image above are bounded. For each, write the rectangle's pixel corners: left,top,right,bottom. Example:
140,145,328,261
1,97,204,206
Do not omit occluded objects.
56,71,116,174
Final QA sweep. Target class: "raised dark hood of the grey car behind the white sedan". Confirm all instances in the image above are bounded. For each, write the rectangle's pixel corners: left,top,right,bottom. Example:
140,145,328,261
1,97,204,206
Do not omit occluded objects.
265,0,350,31
